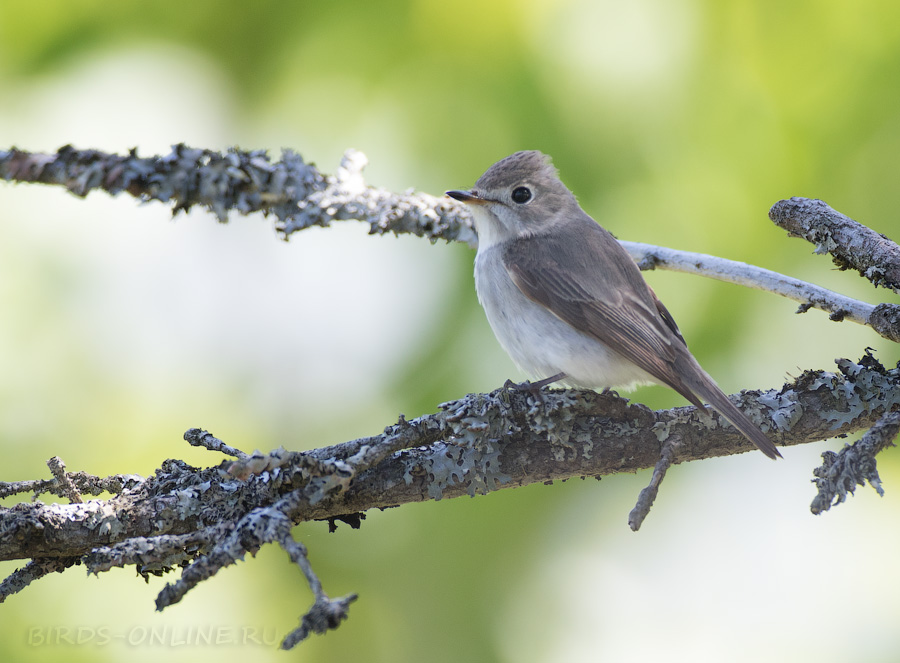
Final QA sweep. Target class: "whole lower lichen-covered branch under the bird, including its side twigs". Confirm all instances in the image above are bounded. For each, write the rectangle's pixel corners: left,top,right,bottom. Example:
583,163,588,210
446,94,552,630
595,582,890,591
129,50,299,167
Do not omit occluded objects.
0,354,900,648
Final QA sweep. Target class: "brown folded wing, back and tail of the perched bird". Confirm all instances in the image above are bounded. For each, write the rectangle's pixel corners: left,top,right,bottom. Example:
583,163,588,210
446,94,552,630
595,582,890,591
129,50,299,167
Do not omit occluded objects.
503,216,781,458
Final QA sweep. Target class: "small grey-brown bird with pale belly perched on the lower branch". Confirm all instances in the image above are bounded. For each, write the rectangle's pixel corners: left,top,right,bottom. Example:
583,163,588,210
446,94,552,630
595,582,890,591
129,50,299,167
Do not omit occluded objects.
446,150,782,459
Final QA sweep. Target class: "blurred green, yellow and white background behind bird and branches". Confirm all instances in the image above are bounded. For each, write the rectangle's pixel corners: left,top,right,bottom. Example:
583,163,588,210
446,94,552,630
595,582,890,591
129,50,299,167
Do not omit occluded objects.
0,0,900,662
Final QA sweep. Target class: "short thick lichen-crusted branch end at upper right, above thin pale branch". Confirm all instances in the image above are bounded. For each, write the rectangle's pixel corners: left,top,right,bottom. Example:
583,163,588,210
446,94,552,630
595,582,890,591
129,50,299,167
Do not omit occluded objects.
769,198,900,293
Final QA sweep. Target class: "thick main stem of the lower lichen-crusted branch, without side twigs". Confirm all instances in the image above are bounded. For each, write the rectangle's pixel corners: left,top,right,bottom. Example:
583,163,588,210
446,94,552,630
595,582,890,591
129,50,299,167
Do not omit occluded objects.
0,355,900,565
